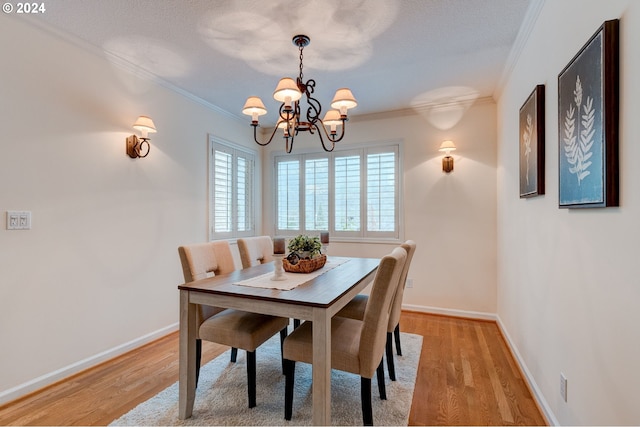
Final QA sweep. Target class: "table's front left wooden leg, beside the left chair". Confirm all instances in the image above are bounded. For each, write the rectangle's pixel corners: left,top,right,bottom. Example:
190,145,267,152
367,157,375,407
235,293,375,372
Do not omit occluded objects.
178,290,196,420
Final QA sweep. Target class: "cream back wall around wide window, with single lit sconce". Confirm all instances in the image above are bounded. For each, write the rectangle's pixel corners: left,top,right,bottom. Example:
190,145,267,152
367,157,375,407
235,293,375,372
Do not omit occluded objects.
263,102,496,316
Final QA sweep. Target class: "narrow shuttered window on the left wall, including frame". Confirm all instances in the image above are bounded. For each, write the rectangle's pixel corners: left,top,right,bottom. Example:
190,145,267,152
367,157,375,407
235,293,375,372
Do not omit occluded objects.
209,137,255,239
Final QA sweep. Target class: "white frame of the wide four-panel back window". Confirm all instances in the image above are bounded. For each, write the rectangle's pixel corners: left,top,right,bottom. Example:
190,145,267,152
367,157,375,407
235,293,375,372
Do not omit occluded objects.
271,141,404,243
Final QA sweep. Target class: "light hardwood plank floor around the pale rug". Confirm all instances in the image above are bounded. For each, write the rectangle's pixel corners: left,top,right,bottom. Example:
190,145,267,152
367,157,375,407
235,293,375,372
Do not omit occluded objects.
0,312,546,426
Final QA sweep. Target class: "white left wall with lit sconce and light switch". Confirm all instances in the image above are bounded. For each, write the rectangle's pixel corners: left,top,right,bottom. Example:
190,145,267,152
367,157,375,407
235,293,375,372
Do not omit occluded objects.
0,14,250,402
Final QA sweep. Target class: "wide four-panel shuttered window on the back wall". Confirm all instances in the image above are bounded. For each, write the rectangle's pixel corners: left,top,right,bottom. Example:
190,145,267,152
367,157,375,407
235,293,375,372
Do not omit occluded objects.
275,144,401,240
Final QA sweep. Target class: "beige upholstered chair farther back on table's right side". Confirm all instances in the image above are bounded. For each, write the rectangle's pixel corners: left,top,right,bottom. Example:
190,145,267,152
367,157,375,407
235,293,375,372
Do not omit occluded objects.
336,240,416,381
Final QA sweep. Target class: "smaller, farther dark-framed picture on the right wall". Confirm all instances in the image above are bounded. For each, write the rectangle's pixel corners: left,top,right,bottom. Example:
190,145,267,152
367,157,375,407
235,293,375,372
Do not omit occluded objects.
519,85,545,198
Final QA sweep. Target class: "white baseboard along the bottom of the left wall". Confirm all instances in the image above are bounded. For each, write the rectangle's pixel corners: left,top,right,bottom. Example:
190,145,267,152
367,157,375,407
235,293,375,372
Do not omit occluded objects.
0,322,178,405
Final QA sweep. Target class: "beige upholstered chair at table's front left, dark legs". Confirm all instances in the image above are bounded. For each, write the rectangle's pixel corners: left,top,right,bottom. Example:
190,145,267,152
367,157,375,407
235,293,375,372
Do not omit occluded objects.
178,240,289,408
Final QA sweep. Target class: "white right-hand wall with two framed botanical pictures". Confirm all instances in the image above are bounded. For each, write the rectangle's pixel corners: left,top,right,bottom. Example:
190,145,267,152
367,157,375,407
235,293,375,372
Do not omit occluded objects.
498,0,640,425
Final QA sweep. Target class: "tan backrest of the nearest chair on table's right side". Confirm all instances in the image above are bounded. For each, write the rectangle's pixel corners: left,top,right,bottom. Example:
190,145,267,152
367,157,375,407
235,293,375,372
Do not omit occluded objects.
359,247,407,378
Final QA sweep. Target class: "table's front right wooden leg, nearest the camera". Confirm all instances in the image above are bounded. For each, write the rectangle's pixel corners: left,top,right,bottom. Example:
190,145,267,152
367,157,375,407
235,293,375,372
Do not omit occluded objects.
312,308,331,426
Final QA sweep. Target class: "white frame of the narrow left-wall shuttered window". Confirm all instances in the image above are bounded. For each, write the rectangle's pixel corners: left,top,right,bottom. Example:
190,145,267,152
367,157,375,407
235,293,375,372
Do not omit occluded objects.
207,135,259,240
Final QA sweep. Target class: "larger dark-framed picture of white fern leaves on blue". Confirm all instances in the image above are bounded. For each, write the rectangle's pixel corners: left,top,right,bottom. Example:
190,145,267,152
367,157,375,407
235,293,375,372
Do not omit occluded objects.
558,19,619,208
